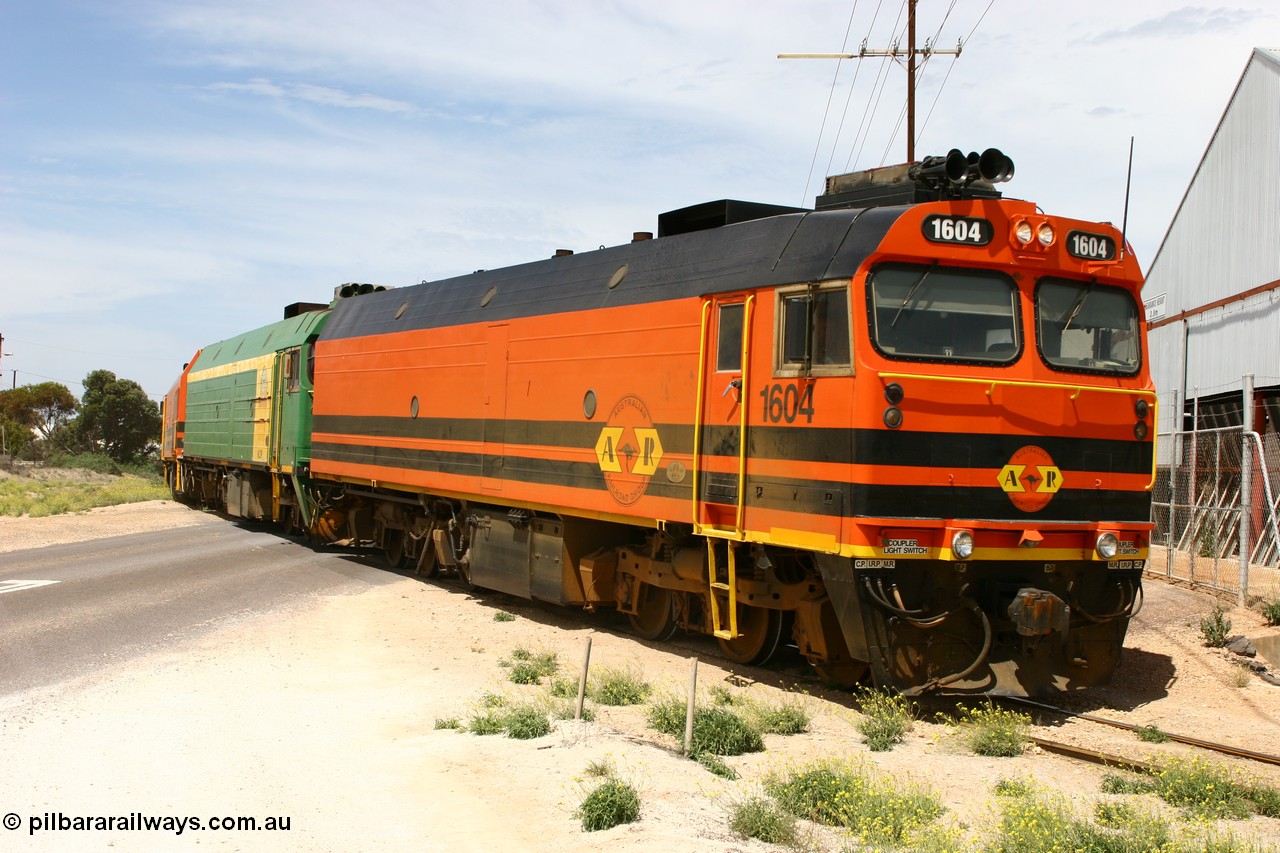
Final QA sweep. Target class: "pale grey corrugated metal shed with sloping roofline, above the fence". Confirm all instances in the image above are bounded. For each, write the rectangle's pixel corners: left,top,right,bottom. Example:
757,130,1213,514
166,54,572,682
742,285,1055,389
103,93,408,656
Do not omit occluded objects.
1143,47,1280,428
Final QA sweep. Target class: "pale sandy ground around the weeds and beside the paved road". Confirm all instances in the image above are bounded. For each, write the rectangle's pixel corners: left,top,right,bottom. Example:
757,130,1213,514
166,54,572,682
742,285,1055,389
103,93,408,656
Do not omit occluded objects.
0,502,1280,853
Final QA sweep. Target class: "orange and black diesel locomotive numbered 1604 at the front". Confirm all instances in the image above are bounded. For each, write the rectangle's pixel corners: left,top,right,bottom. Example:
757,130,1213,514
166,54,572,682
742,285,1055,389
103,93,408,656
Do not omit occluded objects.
165,150,1155,694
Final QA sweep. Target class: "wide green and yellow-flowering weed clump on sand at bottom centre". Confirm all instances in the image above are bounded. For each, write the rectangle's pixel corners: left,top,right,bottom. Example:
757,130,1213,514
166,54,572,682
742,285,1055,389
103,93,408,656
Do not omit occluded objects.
764,761,943,845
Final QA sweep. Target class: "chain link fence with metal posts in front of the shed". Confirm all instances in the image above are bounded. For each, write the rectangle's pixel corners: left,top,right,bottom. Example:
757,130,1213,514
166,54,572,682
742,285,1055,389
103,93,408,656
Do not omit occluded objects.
1148,427,1280,603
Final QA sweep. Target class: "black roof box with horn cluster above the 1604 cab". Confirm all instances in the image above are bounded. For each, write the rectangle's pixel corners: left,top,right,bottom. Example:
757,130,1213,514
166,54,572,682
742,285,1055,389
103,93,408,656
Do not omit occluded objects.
814,149,1014,210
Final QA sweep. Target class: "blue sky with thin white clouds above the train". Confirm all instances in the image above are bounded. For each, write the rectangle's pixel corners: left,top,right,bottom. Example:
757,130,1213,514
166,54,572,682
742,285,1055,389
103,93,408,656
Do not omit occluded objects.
0,0,1280,397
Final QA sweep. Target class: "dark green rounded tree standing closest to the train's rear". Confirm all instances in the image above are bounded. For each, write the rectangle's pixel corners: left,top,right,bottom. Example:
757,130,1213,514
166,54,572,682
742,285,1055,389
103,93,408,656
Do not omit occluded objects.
76,370,160,462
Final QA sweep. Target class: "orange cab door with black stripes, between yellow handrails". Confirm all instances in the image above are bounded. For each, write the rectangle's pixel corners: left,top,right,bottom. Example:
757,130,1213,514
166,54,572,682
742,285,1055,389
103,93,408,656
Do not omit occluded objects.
694,295,755,539
